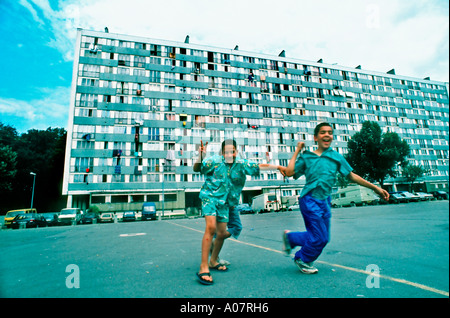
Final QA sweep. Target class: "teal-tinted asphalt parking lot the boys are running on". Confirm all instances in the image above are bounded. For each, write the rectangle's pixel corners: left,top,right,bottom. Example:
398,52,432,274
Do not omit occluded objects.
0,201,449,301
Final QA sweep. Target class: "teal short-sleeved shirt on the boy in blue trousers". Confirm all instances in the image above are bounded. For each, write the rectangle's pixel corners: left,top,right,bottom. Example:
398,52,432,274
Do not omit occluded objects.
293,148,353,200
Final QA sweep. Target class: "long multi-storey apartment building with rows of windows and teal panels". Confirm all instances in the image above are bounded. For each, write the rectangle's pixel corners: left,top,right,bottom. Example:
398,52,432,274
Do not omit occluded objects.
63,29,449,211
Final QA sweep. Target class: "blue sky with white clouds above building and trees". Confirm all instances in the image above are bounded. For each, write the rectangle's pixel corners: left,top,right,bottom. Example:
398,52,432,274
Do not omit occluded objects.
0,0,449,133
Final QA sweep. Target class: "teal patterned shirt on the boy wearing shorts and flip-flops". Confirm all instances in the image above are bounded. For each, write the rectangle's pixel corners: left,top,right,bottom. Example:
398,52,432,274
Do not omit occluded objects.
199,155,260,206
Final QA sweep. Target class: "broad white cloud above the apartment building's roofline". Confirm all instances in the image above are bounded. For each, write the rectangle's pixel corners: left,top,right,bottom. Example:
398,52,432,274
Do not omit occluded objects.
16,0,448,81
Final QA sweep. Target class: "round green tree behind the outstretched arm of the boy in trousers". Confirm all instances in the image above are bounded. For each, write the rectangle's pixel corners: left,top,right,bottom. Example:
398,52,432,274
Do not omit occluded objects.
346,121,409,186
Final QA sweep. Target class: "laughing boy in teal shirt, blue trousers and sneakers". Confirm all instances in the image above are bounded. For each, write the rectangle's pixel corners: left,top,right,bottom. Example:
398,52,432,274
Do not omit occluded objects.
283,123,389,274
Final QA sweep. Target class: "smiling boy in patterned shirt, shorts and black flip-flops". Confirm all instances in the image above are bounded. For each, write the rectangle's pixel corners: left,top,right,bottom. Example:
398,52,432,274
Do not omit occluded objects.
194,139,284,285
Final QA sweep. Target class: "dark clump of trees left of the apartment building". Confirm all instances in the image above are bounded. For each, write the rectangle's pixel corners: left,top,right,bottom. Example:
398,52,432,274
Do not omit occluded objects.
0,123,66,213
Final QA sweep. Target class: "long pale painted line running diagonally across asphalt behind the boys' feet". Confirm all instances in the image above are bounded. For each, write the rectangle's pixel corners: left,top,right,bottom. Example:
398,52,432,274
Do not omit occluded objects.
167,221,449,297
